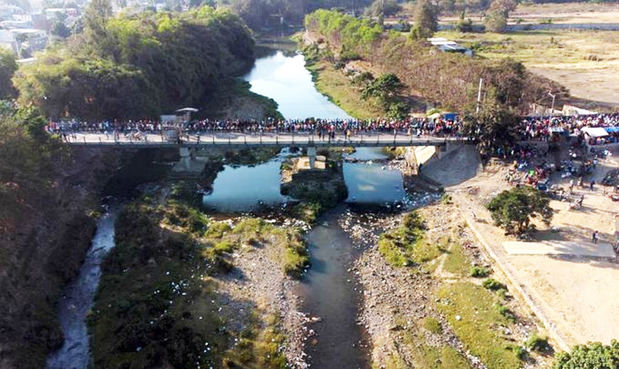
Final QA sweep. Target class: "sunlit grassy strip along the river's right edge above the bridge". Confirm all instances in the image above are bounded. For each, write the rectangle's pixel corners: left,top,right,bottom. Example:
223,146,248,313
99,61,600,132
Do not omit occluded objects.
306,60,385,119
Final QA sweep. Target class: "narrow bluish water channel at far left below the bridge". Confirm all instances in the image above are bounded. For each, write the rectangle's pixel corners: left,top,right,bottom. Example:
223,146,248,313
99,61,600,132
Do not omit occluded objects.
47,206,119,369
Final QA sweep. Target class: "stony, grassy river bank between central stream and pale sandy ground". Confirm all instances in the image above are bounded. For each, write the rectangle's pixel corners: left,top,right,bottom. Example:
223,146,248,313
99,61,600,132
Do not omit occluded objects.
345,198,548,369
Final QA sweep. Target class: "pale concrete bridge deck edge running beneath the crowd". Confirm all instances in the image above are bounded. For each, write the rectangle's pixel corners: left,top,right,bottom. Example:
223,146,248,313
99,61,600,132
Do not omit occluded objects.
67,133,471,148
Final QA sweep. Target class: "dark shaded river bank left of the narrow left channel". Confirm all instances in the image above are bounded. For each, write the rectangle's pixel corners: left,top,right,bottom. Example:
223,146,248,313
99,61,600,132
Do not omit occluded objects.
0,149,122,368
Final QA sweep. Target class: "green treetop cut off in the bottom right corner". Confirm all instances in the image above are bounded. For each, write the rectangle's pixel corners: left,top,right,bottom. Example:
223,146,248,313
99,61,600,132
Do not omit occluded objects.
553,340,619,369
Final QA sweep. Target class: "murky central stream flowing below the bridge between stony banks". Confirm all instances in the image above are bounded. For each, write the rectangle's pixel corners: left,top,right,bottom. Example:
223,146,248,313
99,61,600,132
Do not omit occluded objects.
299,206,369,369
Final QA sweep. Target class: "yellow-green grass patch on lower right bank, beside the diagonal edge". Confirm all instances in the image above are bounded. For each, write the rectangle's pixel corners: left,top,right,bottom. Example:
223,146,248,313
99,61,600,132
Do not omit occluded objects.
438,282,520,369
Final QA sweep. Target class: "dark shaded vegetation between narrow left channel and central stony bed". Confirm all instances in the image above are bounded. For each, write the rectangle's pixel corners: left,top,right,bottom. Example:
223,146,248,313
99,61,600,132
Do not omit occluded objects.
89,199,309,369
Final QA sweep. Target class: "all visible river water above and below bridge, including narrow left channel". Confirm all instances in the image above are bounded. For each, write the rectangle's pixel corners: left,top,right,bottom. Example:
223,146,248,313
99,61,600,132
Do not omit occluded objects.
47,46,406,369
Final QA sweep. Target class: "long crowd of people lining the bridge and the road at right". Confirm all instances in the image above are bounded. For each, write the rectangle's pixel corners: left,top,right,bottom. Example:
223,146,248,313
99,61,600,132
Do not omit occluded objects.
47,113,619,144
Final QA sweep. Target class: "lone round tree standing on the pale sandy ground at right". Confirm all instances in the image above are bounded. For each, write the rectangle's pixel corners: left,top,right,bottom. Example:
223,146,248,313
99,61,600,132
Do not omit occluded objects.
487,186,553,234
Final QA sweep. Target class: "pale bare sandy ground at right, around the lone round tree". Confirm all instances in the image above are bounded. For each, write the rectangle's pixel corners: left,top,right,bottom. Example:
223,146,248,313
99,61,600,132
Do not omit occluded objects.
440,145,619,349
